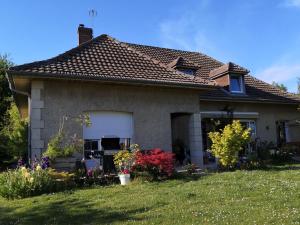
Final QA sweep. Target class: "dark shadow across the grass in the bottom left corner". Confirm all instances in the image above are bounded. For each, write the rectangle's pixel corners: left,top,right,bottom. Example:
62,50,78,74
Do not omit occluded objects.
0,199,154,225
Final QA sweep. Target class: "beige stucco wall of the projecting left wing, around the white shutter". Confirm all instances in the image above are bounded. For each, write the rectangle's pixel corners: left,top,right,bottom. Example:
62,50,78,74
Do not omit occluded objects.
42,80,200,153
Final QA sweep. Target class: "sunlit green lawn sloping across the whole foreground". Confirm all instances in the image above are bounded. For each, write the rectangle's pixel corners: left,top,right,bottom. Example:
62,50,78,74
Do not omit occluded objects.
0,165,300,224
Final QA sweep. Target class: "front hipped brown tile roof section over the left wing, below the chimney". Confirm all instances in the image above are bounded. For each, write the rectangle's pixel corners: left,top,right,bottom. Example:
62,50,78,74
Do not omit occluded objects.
9,35,214,87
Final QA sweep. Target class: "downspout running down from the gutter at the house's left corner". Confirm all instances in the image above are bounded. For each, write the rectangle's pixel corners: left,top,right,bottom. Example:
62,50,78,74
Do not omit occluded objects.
6,73,31,164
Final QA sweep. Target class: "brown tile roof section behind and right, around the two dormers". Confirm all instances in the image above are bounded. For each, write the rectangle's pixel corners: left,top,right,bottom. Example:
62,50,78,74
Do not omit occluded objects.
129,44,300,104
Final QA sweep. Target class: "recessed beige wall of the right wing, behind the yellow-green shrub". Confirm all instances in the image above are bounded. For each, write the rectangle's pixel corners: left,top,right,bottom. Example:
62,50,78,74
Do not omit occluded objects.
201,101,300,143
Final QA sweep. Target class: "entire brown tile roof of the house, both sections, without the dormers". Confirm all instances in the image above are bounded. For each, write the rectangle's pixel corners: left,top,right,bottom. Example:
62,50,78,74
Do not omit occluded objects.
8,35,300,103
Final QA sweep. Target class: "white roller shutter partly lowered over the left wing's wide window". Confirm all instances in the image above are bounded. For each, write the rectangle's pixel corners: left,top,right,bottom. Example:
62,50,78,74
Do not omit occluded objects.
83,111,133,139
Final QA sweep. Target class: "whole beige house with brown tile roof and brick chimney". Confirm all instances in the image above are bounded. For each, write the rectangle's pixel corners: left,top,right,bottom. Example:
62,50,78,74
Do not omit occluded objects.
7,25,300,169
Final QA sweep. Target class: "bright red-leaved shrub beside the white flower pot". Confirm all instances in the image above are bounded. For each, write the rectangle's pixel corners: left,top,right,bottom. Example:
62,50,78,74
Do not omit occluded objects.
132,148,174,179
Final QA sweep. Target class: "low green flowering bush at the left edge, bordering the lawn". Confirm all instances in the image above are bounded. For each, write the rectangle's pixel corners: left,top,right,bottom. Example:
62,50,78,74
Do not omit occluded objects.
0,166,73,199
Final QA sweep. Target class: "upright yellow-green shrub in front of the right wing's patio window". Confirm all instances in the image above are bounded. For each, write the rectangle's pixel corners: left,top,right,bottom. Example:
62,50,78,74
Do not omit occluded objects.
209,120,250,167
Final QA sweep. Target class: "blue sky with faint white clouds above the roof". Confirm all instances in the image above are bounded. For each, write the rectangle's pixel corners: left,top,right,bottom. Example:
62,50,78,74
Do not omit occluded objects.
0,0,300,92
